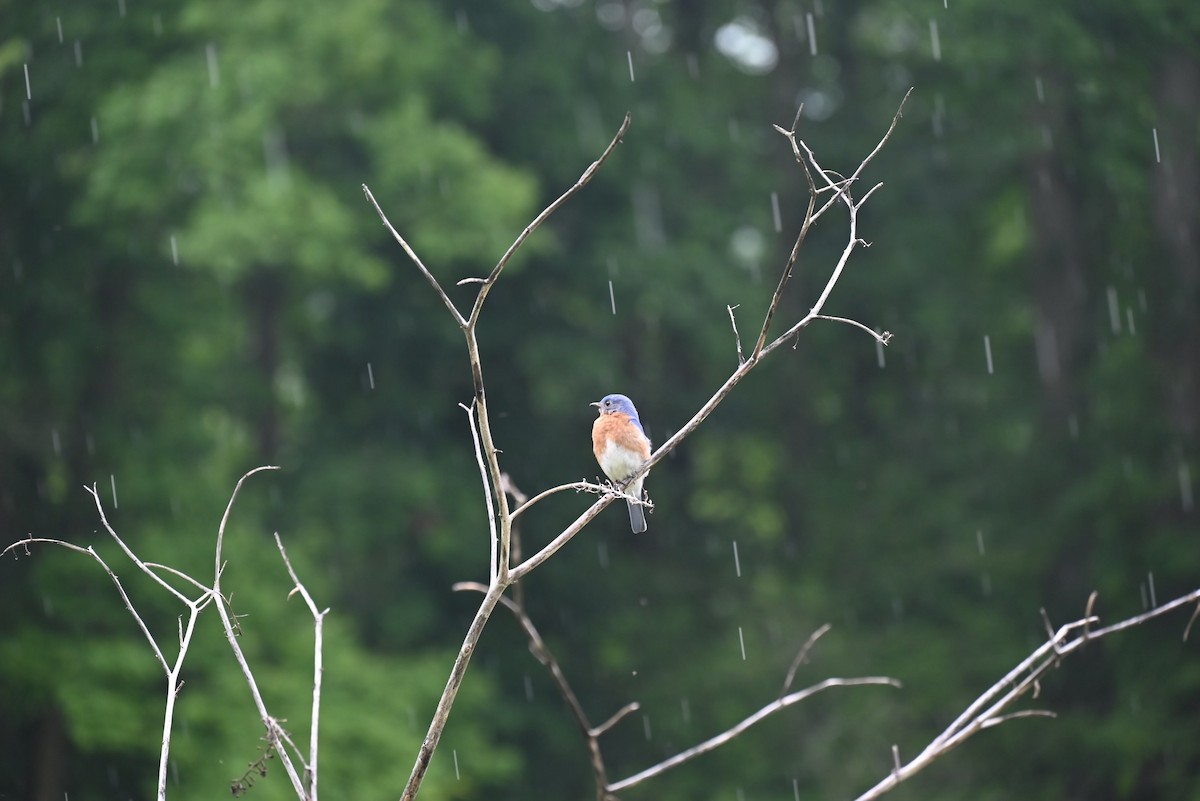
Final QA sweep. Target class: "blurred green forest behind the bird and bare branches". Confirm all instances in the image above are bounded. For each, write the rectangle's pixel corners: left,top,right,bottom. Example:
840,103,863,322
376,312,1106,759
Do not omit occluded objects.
0,0,1200,801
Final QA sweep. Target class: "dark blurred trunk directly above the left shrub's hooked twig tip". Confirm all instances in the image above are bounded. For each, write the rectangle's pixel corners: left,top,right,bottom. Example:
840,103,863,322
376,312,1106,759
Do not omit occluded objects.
246,267,284,463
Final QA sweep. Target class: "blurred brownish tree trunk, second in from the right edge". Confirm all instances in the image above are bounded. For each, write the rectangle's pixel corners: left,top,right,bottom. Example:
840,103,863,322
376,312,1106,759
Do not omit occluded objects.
1027,72,1087,421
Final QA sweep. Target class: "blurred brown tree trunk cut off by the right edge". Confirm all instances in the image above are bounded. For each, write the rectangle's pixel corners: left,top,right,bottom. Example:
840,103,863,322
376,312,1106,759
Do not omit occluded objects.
1151,52,1200,440
